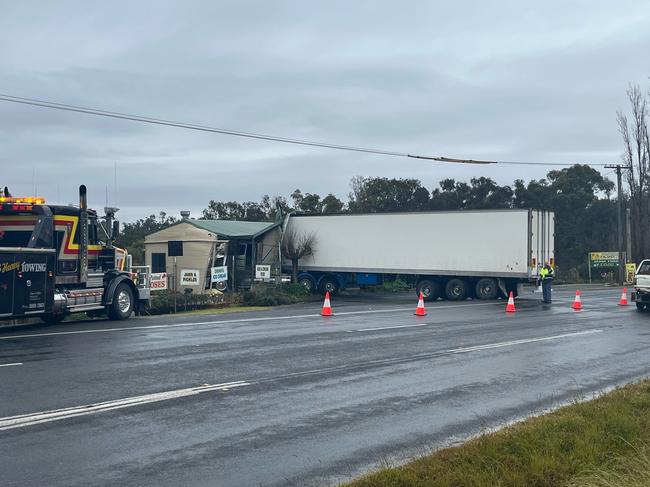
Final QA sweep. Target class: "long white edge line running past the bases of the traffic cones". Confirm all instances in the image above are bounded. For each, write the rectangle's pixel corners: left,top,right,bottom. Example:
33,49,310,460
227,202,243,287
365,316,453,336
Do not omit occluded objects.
0,303,501,340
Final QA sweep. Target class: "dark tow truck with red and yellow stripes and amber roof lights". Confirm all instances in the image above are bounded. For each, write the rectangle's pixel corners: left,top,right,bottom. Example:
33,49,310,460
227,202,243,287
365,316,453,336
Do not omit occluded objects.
0,185,150,323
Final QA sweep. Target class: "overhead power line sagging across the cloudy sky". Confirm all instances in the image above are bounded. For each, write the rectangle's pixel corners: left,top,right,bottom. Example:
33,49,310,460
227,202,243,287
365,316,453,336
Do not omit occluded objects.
0,94,605,166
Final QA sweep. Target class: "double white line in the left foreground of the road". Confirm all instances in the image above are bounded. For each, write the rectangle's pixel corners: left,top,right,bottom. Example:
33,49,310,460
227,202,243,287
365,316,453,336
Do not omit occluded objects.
0,381,250,431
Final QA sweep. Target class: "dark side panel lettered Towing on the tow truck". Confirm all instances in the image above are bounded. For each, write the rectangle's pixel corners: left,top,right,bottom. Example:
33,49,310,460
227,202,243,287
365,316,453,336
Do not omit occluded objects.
0,248,55,318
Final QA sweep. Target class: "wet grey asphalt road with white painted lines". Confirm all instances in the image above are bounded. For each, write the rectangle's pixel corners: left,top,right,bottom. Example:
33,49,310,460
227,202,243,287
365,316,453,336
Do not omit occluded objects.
0,289,650,486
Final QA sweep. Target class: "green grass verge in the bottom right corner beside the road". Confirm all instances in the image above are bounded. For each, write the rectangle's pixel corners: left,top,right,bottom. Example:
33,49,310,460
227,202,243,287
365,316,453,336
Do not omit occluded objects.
346,381,650,487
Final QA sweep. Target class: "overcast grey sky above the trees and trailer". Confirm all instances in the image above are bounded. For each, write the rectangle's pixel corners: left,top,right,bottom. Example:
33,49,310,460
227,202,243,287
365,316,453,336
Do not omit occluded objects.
0,0,650,220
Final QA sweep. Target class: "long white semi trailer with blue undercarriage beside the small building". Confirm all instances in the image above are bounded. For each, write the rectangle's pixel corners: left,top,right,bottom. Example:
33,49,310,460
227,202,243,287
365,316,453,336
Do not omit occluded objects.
284,209,555,301
